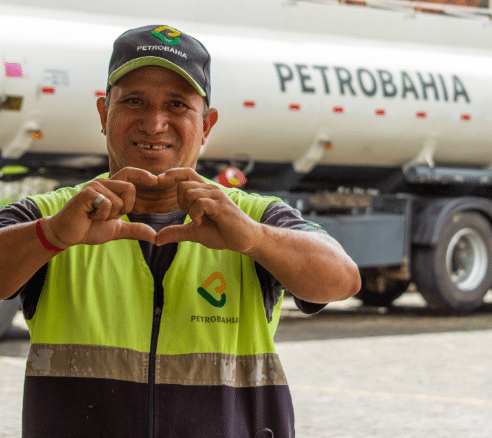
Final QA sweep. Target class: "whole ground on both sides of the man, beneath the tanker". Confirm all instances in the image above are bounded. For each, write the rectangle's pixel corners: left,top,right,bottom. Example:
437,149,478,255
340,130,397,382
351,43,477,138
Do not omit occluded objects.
0,294,492,438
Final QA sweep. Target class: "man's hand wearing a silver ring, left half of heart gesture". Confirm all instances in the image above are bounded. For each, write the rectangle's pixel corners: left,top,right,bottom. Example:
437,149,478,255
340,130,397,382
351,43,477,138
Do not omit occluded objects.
41,167,158,249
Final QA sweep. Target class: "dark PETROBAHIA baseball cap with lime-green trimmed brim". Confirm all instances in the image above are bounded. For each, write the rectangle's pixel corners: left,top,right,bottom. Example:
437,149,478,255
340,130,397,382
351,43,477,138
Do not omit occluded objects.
108,25,211,105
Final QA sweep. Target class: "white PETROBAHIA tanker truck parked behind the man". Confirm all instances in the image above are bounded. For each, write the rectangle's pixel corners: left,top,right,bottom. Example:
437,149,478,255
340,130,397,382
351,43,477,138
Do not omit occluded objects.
0,0,492,336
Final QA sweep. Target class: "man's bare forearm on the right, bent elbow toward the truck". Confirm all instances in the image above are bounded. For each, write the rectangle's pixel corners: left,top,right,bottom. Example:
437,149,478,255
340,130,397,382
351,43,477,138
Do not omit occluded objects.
246,224,360,303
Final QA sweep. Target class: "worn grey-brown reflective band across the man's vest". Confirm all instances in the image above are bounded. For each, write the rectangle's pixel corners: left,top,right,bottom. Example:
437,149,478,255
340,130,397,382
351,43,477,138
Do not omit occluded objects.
26,344,287,387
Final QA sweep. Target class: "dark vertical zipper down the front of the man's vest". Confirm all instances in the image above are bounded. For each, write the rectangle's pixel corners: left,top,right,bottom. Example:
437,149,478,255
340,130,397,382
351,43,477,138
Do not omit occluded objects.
147,283,164,438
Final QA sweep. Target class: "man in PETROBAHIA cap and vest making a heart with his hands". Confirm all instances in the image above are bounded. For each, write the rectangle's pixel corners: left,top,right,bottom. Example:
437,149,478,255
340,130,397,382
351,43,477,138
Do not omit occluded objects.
0,26,360,438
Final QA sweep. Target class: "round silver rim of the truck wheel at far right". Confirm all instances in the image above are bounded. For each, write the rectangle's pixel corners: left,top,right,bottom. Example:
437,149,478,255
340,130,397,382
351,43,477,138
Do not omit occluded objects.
446,228,489,291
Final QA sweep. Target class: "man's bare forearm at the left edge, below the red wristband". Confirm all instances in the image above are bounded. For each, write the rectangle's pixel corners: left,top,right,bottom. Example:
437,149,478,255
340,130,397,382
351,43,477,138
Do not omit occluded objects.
0,222,56,299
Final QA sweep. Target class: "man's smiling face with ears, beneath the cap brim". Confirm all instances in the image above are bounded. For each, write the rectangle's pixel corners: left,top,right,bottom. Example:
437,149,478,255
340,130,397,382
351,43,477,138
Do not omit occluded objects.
98,66,218,175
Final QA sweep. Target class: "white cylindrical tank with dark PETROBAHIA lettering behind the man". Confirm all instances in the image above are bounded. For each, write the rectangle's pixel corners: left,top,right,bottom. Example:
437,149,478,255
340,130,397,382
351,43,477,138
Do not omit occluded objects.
0,1,492,171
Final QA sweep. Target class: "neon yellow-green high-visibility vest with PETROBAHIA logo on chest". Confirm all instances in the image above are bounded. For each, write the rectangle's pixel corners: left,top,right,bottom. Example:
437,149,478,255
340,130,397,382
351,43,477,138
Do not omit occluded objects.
24,176,293,437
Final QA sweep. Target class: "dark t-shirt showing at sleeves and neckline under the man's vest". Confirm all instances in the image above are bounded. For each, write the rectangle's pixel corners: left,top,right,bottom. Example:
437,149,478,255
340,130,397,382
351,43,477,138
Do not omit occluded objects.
0,199,326,320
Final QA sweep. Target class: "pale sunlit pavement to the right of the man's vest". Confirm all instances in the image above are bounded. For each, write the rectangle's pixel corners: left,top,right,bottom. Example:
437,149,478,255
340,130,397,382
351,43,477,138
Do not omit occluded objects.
278,331,492,438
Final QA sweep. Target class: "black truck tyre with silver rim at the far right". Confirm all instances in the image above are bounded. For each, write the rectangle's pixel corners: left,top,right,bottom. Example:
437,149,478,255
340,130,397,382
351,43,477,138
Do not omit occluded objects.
412,212,492,312
